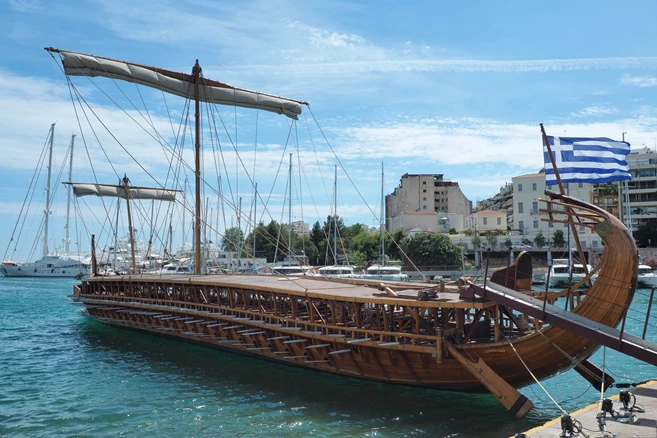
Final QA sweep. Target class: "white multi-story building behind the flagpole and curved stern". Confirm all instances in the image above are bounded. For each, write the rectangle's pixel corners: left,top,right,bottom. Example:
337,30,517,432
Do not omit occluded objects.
511,173,601,248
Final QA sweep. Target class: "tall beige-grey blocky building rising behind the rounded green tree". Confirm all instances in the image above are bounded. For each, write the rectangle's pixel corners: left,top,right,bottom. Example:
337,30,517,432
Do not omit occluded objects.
386,173,472,230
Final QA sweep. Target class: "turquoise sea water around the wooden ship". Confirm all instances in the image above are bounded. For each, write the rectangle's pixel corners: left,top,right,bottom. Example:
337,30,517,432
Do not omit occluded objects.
0,278,657,437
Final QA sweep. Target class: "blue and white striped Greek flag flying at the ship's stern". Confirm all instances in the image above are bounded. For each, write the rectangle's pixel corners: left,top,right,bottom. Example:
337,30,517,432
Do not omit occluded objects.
543,137,632,185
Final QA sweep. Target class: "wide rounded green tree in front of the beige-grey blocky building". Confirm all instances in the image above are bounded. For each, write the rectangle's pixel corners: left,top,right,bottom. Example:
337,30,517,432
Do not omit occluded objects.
404,233,464,266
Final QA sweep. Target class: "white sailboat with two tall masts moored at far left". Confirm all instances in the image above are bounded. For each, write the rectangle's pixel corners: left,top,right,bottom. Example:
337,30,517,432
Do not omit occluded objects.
0,123,91,278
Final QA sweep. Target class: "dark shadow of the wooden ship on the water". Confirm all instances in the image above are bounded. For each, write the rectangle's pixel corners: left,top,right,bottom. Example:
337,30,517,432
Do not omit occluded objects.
79,319,548,437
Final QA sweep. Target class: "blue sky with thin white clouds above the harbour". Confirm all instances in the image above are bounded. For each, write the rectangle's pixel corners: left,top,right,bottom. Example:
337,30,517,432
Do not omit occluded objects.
0,0,657,259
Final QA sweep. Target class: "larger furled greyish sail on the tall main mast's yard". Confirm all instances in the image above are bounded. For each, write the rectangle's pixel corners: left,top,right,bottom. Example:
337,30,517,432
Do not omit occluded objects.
46,48,307,119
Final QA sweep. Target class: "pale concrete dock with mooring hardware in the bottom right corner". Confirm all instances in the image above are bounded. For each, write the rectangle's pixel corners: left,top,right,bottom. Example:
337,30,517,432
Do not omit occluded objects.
515,380,657,438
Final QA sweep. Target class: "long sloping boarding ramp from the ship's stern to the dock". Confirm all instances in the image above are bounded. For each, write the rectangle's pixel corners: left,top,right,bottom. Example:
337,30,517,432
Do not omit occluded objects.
471,282,657,366
